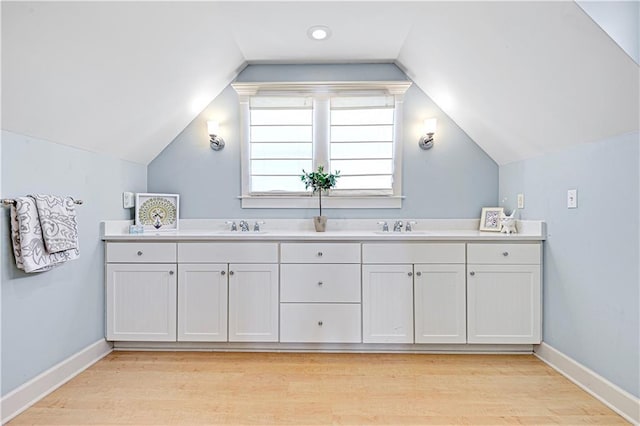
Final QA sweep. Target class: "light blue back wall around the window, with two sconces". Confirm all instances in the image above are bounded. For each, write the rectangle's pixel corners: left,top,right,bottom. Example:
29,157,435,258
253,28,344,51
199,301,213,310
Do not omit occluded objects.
148,64,498,218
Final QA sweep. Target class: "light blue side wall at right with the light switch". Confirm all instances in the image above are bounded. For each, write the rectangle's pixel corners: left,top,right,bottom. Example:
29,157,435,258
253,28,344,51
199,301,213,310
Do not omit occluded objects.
500,133,640,396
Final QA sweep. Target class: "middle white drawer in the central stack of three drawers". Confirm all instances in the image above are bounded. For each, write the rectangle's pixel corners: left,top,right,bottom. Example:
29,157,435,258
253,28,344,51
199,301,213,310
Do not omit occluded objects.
280,264,360,303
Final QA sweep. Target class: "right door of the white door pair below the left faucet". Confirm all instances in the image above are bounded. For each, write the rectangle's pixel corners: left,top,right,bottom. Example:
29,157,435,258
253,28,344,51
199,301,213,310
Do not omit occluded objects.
229,264,279,342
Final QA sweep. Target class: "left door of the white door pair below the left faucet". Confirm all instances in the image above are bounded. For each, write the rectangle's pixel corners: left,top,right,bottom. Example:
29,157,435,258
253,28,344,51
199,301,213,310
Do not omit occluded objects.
178,263,227,342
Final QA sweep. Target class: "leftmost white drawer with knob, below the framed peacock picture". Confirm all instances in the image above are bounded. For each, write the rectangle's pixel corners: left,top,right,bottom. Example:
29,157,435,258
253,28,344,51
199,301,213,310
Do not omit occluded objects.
106,243,176,263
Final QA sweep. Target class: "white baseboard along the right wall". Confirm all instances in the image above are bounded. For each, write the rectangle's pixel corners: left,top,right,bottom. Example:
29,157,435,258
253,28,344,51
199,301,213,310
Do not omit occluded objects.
534,342,640,425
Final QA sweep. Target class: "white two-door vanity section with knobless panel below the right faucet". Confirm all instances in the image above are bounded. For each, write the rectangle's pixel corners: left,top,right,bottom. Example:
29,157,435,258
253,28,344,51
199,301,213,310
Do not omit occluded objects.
362,242,466,343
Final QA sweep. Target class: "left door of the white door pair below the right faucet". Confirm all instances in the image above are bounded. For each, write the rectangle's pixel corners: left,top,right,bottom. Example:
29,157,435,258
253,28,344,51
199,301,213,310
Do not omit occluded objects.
362,265,413,343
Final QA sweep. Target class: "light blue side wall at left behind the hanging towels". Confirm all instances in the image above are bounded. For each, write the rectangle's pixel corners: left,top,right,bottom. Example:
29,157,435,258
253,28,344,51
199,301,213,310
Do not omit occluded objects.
0,131,147,395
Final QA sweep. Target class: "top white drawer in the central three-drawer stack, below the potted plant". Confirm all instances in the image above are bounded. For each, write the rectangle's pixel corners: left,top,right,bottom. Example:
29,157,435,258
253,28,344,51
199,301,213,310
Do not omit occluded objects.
280,243,360,263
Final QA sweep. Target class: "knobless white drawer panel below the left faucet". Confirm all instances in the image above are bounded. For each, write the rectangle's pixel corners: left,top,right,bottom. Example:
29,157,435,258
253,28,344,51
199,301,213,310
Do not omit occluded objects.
178,243,278,263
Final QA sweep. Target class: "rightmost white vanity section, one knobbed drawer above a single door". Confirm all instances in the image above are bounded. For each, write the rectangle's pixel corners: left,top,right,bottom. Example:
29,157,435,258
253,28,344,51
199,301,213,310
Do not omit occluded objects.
467,243,542,344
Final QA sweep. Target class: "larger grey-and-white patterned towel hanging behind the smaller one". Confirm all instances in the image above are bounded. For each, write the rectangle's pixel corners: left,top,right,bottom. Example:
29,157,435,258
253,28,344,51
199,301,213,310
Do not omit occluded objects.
11,197,80,272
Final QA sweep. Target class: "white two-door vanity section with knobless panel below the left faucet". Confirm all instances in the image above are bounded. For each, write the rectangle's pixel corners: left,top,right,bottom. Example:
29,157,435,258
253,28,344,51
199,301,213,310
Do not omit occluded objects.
178,242,279,342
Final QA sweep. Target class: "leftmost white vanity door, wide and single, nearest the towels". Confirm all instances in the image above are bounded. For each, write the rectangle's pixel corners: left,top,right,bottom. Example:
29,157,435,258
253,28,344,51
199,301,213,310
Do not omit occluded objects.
106,263,177,342
